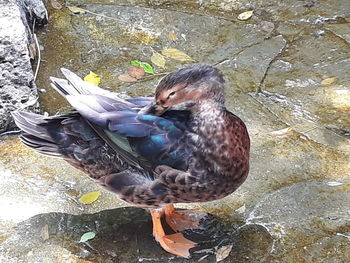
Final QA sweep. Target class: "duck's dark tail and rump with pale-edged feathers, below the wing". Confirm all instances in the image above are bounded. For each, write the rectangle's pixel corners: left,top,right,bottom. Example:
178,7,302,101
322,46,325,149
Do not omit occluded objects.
12,111,150,179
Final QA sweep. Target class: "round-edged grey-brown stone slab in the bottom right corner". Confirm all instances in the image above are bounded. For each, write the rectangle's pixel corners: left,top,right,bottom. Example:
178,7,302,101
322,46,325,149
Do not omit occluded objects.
247,183,350,262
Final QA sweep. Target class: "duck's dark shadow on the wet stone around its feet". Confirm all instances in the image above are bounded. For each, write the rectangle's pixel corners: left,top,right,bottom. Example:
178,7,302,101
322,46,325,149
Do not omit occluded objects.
2,207,272,263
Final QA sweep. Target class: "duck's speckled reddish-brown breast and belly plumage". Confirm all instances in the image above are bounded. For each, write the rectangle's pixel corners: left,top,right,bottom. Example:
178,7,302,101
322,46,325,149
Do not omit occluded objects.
102,102,250,206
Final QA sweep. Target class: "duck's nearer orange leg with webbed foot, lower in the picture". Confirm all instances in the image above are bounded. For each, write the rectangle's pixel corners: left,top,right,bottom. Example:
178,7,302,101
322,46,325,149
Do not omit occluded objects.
151,206,196,258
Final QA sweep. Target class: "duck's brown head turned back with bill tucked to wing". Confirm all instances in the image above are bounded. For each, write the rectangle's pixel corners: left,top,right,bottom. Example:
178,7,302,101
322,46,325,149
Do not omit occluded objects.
148,64,225,115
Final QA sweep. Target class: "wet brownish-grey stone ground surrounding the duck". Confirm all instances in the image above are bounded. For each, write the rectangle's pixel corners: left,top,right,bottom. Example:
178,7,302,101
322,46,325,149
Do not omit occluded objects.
0,0,350,262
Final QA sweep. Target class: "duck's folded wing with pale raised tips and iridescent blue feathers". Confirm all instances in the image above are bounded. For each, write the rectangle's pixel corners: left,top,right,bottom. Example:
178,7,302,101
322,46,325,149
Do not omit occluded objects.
51,69,187,170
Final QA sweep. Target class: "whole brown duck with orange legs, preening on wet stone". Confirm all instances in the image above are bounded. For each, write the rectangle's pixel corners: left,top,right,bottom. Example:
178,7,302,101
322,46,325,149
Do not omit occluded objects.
12,64,250,258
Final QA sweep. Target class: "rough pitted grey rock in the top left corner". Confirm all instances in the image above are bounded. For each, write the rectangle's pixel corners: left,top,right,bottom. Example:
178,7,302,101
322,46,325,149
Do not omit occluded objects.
0,0,46,133
